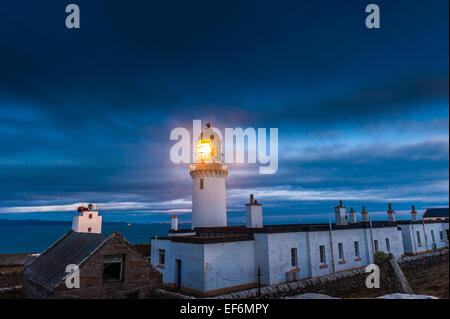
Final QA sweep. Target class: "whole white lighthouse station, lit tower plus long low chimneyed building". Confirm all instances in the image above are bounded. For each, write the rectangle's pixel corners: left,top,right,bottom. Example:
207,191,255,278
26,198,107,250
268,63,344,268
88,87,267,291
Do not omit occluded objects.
151,126,448,296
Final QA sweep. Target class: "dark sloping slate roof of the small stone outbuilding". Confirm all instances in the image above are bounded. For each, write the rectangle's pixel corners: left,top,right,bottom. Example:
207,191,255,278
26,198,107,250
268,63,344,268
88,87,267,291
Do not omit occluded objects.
24,230,113,291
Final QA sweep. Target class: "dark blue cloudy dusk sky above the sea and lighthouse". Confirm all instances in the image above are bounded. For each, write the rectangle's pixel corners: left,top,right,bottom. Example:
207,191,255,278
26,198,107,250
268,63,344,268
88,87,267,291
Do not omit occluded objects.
0,0,449,222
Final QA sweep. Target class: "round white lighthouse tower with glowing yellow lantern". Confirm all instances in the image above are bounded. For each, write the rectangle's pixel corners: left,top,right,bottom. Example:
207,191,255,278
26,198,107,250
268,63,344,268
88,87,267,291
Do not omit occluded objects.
190,123,228,228
